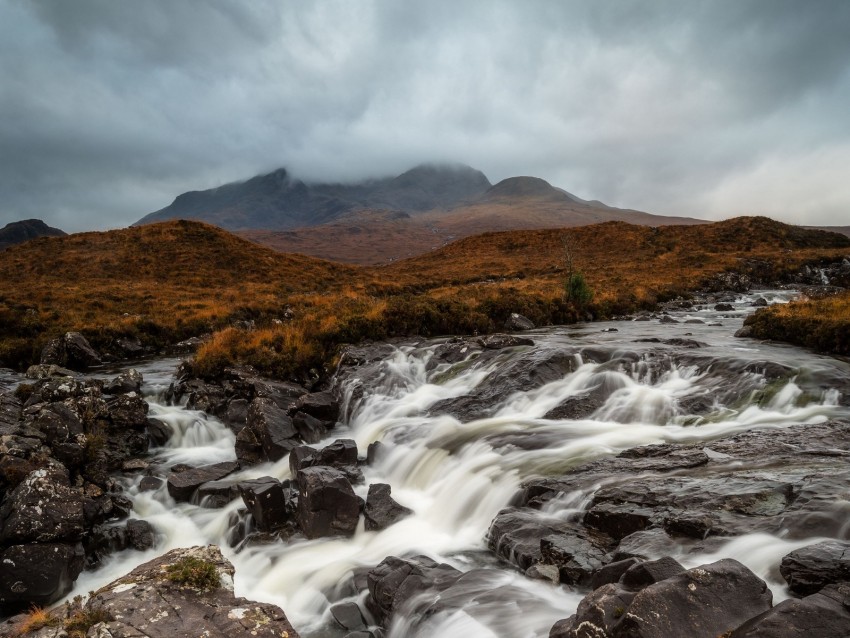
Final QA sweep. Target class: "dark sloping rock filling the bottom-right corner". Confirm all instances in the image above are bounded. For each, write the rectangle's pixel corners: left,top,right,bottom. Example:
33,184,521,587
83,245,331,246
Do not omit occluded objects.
729,584,850,638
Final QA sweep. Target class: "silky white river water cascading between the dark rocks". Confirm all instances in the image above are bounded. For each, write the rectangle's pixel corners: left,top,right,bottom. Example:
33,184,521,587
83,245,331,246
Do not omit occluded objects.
26,292,850,638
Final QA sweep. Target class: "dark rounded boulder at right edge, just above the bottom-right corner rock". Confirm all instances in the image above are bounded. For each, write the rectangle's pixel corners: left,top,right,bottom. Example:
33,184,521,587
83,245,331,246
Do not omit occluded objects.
779,541,850,596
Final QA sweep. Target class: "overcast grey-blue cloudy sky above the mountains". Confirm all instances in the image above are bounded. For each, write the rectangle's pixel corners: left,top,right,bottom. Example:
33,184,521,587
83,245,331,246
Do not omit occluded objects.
0,0,850,231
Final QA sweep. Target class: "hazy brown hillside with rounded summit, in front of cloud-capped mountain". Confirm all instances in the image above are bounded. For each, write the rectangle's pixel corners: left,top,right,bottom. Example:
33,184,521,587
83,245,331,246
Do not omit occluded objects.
240,177,705,265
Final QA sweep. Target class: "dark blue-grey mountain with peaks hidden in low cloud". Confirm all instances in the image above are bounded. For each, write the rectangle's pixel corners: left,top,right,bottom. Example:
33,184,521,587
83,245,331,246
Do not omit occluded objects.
136,164,490,230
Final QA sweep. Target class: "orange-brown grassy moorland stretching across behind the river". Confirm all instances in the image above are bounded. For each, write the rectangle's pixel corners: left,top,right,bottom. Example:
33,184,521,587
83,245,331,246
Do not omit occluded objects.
0,218,850,381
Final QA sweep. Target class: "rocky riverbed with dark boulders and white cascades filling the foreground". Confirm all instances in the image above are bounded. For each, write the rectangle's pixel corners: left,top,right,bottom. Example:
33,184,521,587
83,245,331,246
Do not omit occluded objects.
0,291,850,638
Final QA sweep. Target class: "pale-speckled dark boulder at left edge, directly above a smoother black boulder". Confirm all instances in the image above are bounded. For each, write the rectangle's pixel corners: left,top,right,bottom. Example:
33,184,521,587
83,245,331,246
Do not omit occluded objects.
0,466,85,545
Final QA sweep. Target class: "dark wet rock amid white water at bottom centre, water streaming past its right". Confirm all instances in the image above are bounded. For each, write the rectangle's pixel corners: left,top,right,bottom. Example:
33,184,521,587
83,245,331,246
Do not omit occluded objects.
367,556,462,625
